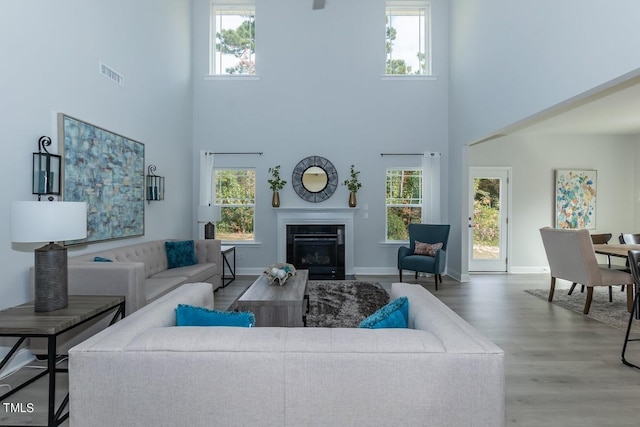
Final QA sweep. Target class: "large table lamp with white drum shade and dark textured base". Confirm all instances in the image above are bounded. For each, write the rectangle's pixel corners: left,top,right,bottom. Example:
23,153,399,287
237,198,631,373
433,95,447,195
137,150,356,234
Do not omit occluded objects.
11,201,87,312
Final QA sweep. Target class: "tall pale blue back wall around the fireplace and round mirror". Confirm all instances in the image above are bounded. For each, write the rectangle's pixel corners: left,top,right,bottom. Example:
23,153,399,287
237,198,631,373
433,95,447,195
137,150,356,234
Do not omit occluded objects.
193,0,448,273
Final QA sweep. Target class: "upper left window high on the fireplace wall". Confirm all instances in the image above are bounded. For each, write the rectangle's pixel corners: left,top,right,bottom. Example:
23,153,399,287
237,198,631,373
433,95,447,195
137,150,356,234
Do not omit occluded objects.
210,4,256,75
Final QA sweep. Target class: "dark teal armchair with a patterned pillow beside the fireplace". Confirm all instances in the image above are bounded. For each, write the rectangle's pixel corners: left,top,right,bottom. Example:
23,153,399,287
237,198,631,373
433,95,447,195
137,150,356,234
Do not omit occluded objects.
398,224,451,291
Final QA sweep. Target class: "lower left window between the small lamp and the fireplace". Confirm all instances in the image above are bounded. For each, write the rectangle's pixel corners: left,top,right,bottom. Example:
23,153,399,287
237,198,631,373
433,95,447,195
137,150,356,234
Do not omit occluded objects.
214,169,256,241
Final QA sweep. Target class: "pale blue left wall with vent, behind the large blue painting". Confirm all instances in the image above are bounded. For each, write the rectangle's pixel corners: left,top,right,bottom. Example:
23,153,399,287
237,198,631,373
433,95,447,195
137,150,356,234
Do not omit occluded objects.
0,0,192,309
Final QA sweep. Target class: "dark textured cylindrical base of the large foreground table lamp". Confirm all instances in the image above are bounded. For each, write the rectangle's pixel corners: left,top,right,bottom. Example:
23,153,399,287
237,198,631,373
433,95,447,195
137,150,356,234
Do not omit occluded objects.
34,243,69,313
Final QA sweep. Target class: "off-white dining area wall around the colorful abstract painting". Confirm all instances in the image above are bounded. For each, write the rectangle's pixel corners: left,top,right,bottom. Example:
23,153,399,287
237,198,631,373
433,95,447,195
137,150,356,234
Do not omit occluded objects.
469,135,640,273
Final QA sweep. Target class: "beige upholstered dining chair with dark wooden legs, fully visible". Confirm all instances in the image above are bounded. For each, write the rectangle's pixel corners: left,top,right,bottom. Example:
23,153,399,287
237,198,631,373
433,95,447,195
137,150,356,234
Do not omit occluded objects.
540,227,633,314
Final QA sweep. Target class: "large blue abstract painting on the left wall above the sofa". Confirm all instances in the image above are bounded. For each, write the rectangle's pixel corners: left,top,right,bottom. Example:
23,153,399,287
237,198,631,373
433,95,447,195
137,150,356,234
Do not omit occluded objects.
58,113,145,245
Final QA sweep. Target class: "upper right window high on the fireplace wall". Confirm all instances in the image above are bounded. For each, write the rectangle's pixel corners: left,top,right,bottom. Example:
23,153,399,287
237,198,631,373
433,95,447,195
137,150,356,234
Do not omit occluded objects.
385,0,431,76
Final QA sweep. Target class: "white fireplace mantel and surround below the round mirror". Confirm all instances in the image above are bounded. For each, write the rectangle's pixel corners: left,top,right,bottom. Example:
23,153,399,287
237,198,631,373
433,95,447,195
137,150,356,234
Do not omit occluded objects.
274,207,358,274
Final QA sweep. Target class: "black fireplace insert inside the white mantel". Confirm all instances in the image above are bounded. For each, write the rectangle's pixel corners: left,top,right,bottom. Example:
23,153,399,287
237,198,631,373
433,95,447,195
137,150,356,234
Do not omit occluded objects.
287,224,345,280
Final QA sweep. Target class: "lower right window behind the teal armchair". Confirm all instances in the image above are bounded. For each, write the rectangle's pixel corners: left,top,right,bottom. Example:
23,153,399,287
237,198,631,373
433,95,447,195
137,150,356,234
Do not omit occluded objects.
386,168,422,240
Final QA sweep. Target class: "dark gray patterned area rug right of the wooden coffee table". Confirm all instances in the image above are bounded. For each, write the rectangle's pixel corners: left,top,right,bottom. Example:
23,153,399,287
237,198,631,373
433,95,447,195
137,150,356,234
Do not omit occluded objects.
306,280,389,328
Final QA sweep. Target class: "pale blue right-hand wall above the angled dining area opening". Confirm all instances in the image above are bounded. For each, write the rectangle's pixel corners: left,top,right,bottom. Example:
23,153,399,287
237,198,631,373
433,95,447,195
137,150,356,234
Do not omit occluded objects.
448,0,640,276
